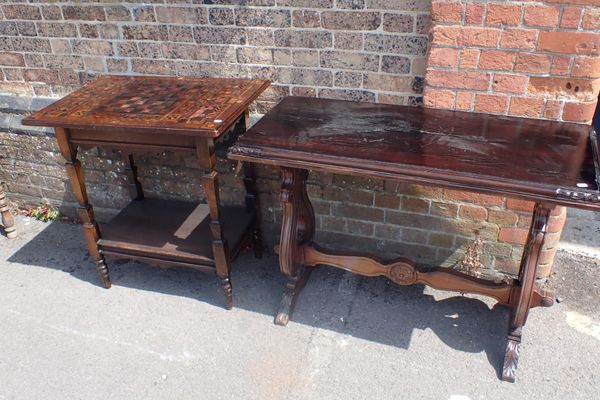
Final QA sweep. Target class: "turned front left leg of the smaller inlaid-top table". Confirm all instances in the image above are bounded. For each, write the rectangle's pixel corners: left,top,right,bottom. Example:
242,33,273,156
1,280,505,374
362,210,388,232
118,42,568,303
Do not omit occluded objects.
55,128,111,289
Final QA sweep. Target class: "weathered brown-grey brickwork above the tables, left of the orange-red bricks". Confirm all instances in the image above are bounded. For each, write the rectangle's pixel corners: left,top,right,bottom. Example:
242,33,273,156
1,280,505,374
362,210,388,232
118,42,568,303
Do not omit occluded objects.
0,0,430,108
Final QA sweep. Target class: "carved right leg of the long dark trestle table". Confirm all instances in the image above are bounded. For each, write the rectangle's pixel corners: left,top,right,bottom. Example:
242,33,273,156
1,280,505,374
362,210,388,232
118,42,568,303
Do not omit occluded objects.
502,203,555,382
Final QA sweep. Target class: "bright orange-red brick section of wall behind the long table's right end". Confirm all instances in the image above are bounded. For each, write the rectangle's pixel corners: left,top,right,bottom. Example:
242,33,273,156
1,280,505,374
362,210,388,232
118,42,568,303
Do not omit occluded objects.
424,0,600,273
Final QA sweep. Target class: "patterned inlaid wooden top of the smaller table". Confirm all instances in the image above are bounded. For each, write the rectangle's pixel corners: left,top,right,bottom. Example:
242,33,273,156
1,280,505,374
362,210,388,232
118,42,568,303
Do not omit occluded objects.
23,75,269,137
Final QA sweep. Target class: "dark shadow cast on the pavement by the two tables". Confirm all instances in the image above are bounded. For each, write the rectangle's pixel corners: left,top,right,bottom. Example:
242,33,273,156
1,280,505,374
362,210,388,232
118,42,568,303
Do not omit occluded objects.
8,222,508,373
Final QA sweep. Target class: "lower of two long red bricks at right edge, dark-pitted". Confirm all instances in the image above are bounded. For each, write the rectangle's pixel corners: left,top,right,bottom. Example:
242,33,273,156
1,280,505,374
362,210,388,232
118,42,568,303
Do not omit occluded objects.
529,76,600,101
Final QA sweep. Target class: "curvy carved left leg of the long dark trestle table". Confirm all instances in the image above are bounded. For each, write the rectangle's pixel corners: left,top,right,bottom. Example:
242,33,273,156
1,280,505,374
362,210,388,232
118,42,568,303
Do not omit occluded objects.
275,168,315,326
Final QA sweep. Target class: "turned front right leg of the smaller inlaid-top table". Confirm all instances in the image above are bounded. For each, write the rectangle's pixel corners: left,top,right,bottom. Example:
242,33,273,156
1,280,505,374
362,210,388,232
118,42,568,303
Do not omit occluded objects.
196,139,233,310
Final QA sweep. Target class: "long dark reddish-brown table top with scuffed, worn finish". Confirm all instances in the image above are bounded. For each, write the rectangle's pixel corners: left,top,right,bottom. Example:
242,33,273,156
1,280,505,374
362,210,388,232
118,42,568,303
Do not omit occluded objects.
230,97,600,208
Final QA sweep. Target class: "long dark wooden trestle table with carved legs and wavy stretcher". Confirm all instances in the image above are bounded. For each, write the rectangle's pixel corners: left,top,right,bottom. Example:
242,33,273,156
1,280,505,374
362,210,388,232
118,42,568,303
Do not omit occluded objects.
229,97,600,381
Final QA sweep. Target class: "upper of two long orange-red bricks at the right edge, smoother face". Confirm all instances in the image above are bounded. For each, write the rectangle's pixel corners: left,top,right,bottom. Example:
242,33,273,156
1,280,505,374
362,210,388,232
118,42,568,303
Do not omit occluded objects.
537,31,600,55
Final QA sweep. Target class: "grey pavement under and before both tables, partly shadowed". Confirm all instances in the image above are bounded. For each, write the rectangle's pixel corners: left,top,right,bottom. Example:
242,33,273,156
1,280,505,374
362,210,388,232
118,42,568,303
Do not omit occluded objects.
0,218,600,400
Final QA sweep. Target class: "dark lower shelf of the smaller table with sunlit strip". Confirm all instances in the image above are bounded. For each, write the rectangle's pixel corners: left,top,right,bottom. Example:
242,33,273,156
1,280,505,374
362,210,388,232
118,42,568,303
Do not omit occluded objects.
98,199,255,269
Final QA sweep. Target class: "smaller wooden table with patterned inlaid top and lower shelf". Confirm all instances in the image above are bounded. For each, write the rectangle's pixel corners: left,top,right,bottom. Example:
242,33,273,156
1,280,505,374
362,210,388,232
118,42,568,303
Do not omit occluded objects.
23,76,269,308
